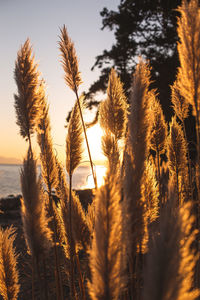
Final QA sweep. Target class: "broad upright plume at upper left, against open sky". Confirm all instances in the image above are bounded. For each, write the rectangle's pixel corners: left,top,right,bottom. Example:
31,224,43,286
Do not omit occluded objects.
14,39,39,143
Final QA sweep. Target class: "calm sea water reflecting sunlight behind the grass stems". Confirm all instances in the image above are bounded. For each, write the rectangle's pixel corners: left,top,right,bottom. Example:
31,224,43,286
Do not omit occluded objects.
0,164,106,198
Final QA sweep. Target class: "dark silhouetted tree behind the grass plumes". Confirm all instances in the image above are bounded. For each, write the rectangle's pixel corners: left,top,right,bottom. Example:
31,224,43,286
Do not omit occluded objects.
87,0,181,119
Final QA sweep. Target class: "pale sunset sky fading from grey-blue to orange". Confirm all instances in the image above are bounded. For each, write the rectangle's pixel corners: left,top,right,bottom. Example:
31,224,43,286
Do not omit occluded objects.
0,0,120,163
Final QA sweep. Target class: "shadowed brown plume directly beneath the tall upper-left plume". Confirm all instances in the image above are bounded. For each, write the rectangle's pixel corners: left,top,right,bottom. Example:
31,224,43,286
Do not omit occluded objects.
21,151,52,262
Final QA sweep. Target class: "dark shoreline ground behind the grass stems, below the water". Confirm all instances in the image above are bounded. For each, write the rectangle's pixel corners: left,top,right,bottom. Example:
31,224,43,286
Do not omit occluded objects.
0,189,93,300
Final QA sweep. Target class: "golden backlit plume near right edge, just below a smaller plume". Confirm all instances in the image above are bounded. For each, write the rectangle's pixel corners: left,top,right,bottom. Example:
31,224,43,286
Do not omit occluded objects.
167,117,189,205
